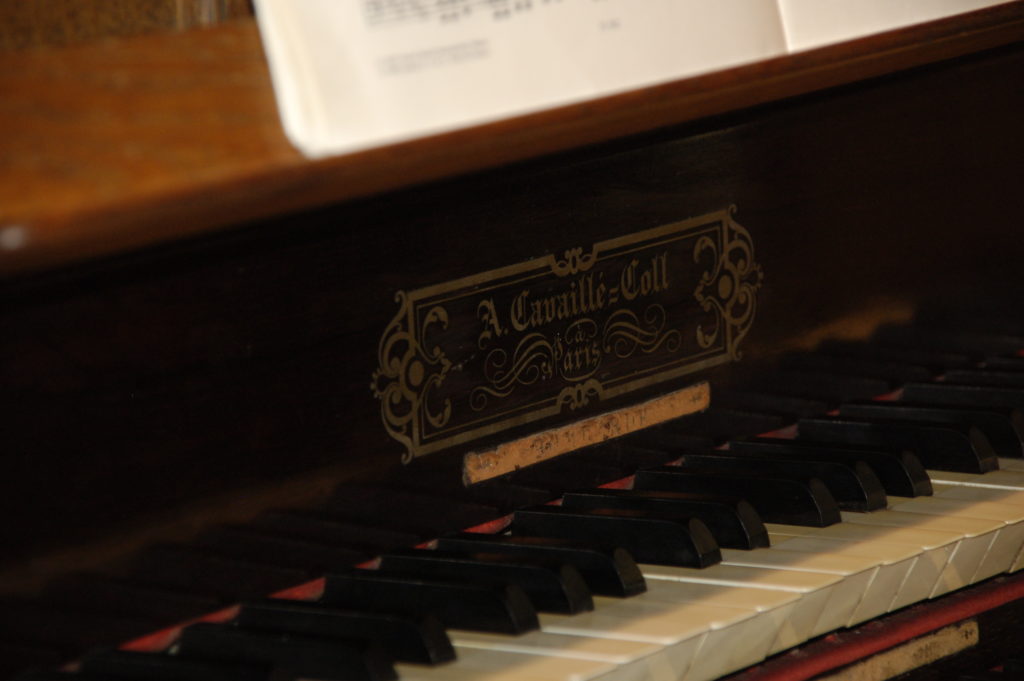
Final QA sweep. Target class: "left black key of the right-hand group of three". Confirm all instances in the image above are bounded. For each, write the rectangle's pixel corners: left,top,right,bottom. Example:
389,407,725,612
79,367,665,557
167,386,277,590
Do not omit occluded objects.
633,466,840,527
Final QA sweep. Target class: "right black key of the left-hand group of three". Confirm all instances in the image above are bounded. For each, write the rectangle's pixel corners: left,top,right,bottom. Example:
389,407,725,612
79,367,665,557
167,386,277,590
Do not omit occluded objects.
437,533,647,598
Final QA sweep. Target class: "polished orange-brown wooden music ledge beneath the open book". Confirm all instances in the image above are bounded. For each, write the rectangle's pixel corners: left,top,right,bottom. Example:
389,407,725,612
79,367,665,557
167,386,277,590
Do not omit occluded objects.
0,1,1024,275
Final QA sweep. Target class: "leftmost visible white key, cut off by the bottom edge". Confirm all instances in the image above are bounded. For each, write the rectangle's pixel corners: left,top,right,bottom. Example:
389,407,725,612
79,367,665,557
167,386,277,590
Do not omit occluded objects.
394,646,622,681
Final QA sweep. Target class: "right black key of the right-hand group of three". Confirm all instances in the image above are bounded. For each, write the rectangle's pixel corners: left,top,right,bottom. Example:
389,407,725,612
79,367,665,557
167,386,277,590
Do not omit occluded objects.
729,437,932,497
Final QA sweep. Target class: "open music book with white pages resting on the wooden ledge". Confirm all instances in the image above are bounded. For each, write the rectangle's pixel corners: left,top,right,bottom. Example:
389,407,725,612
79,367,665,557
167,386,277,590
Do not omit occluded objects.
255,0,1006,157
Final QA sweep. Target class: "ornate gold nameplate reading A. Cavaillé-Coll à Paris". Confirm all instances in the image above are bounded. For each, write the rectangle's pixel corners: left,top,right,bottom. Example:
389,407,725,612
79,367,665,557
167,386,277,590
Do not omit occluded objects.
371,208,763,462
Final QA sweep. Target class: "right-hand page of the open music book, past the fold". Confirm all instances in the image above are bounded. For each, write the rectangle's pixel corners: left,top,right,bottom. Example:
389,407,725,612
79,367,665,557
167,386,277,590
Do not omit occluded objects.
778,0,1009,51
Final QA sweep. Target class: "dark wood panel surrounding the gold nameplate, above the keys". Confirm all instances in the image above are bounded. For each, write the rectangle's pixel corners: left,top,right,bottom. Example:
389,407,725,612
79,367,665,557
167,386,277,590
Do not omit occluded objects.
0,42,1024,560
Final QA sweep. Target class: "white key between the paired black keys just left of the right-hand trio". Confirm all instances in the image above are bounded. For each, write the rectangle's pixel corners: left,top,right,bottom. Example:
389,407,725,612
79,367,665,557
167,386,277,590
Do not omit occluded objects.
722,545,905,627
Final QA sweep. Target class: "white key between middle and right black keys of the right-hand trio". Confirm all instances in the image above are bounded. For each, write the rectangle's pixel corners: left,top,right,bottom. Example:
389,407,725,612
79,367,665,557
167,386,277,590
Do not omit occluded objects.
892,497,1024,582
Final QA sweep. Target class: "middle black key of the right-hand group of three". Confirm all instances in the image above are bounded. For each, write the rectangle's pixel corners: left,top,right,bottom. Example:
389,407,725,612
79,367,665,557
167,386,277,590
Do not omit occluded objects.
680,451,886,512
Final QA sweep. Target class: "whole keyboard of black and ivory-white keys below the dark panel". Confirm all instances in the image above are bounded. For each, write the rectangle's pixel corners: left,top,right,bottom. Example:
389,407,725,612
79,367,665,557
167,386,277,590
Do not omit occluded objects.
9,327,1024,681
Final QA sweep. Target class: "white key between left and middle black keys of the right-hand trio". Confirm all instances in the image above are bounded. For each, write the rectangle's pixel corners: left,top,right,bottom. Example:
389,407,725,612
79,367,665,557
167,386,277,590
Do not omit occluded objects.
842,511,1005,598
